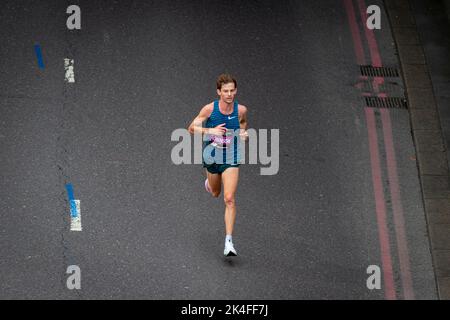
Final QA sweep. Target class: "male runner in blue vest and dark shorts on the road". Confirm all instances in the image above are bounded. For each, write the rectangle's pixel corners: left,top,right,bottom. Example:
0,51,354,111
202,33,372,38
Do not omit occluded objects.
189,74,248,256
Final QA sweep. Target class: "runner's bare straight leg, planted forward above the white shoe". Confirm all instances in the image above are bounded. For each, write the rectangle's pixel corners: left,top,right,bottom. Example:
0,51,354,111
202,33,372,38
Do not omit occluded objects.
222,167,239,235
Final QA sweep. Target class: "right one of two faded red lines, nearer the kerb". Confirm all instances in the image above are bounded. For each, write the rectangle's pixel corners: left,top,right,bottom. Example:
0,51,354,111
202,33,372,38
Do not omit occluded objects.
358,0,414,300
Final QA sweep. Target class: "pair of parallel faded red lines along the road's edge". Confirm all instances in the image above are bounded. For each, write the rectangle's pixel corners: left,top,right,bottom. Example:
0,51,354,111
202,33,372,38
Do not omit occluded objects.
343,0,414,300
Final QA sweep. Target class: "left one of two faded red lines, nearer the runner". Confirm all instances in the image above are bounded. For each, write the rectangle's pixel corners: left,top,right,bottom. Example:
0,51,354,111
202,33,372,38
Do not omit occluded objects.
343,0,396,300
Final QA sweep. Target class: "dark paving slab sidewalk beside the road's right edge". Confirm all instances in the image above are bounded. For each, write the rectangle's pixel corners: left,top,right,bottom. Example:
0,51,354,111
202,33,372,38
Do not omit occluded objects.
384,0,450,299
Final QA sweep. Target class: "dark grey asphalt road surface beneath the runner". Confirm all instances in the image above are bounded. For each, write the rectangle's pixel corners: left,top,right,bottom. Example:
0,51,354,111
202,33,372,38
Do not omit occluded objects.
0,0,437,299
